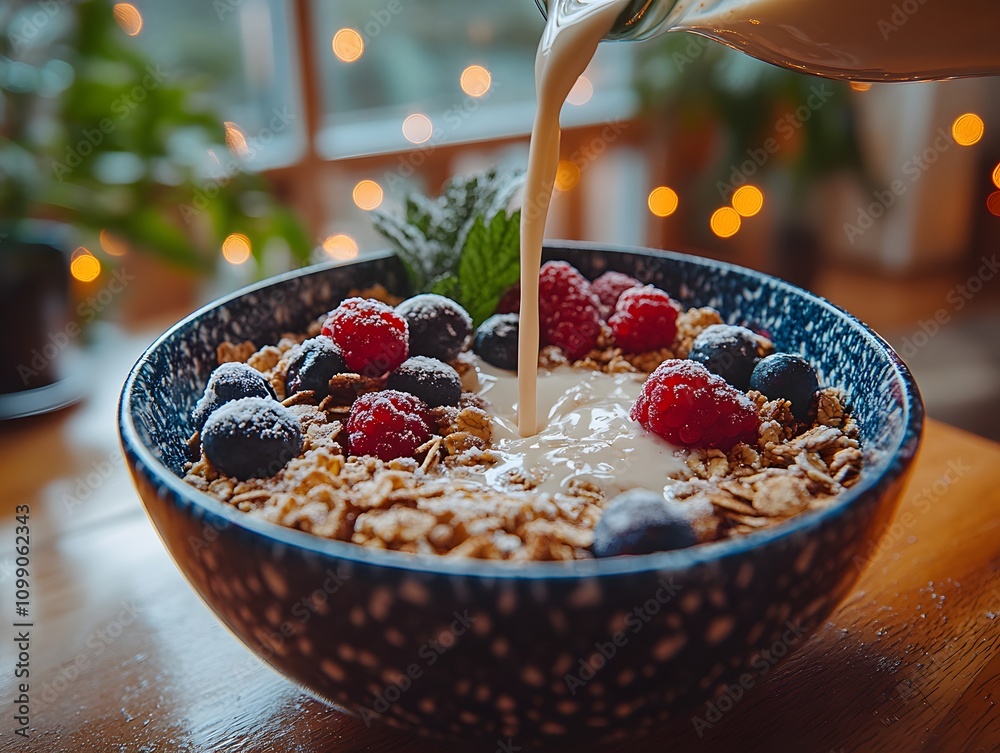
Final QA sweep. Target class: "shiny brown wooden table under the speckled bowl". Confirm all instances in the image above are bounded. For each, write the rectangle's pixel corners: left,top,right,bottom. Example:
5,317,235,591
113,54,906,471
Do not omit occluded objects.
0,324,1000,753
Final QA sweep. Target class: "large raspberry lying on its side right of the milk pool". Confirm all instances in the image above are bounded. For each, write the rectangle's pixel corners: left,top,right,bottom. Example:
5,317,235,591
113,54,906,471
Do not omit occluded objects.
629,358,760,450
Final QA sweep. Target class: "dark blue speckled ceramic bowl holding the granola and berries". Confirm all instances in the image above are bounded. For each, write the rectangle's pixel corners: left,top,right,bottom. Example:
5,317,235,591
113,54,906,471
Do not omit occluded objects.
119,244,923,750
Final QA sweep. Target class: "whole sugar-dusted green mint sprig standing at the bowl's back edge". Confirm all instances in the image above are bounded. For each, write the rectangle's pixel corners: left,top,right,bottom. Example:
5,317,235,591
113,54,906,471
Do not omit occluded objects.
373,169,524,326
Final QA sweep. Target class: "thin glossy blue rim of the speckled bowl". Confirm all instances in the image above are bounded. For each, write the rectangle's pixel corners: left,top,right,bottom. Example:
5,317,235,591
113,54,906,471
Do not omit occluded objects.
118,241,924,580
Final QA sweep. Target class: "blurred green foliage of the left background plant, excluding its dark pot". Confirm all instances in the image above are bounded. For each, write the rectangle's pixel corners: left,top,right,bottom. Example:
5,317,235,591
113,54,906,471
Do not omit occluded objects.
0,0,311,271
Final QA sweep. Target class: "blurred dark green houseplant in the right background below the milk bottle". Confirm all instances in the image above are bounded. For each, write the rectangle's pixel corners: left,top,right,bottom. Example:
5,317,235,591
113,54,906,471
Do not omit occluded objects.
634,34,869,285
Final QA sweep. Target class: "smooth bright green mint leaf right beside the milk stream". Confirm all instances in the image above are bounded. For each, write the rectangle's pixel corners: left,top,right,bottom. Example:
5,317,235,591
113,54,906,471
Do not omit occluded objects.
457,211,521,327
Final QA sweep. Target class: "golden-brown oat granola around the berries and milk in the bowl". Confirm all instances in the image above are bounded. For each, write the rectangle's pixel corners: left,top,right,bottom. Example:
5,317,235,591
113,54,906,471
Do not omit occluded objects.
185,302,862,560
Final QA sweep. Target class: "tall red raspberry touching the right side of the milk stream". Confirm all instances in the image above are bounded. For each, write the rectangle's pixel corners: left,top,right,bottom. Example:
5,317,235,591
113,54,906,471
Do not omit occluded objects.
538,261,601,361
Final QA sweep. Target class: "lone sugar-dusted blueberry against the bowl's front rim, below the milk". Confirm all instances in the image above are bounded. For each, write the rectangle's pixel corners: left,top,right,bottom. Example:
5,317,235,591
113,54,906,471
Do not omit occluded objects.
594,489,698,557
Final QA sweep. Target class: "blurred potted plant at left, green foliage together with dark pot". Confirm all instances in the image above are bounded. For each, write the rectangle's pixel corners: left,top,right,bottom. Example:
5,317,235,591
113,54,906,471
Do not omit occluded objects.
0,0,311,408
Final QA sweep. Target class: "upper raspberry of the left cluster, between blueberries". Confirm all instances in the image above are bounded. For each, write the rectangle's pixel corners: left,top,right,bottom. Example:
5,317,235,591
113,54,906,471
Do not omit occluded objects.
323,298,409,377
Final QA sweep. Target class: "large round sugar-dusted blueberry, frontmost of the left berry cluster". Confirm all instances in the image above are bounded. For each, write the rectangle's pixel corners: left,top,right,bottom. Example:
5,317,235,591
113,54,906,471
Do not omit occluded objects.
201,397,302,480
